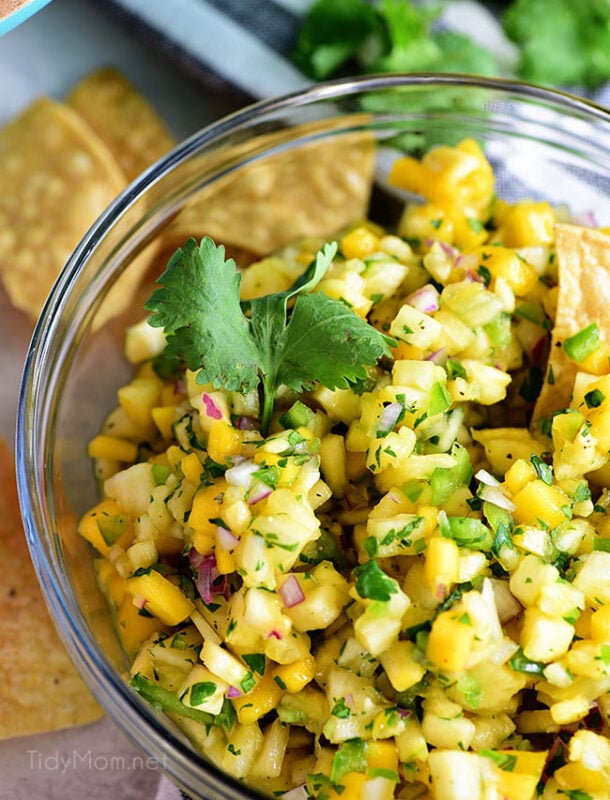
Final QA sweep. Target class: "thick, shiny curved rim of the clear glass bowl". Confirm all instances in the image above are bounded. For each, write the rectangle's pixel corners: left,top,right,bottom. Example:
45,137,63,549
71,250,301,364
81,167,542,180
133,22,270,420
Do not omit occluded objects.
16,73,610,800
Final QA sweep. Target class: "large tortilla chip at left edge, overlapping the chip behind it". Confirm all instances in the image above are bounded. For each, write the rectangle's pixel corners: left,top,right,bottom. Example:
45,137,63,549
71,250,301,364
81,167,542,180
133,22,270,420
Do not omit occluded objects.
0,98,127,317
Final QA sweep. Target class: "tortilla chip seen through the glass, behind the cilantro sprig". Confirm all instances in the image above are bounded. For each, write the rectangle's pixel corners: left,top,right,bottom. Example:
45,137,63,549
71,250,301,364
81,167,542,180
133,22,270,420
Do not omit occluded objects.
168,128,375,256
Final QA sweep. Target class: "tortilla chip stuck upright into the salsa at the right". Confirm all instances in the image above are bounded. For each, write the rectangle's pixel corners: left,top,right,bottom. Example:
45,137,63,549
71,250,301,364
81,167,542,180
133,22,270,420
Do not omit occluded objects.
533,225,610,421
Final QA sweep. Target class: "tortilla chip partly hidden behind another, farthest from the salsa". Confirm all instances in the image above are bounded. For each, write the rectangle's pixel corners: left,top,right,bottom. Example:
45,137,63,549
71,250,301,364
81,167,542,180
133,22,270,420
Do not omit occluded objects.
66,67,175,181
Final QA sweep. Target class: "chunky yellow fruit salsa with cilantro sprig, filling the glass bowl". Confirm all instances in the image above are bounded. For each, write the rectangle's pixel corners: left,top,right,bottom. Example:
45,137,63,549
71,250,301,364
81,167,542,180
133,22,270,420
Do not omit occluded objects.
79,140,610,800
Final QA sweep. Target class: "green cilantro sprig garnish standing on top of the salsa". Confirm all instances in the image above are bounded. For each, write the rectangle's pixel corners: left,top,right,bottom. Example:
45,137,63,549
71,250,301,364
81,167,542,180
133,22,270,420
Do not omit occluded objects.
145,237,394,433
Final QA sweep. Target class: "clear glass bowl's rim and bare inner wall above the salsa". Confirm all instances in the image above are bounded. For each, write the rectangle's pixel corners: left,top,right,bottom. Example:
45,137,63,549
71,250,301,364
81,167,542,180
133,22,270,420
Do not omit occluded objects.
17,75,610,800
